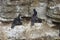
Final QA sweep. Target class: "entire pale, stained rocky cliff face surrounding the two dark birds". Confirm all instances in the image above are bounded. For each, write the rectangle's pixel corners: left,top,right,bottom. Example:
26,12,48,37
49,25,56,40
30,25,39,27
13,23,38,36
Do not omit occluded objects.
0,0,60,40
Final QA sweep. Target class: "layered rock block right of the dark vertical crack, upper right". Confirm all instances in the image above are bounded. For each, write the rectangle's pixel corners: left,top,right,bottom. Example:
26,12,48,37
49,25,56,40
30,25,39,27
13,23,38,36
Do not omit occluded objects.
47,0,60,22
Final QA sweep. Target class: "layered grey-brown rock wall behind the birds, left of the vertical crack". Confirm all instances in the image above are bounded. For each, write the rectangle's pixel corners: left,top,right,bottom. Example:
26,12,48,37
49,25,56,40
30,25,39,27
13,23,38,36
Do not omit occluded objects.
0,0,47,19
